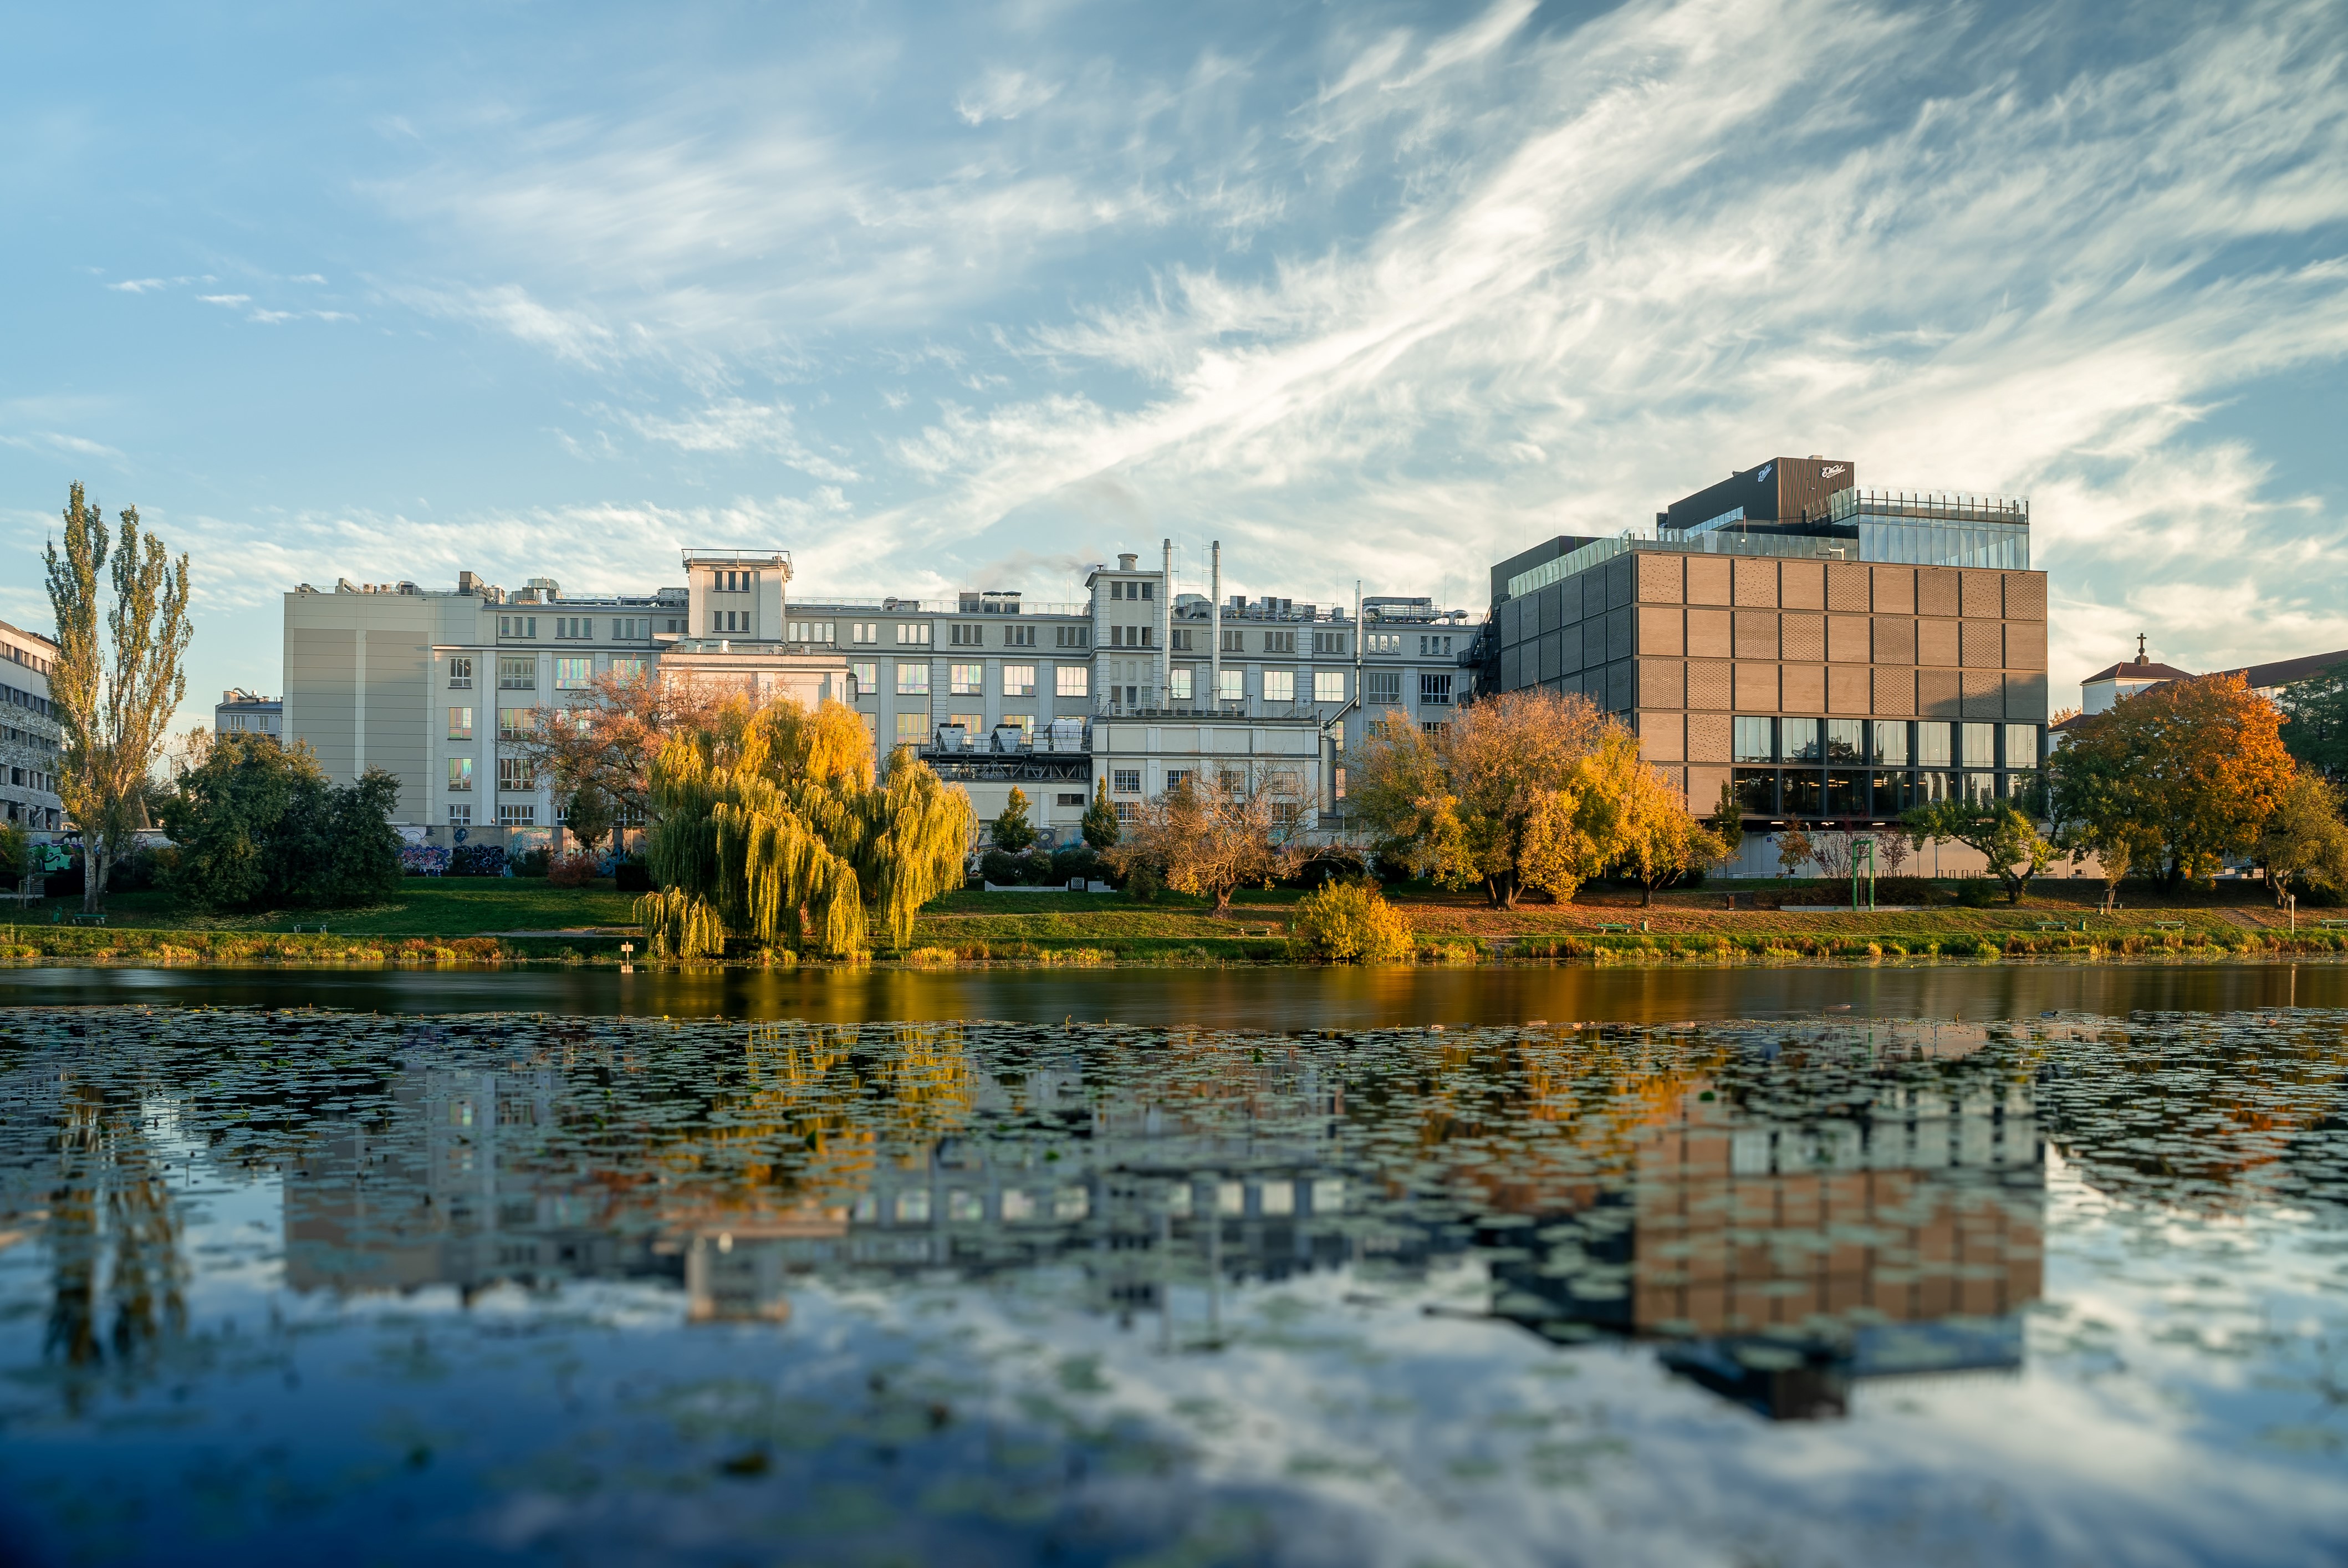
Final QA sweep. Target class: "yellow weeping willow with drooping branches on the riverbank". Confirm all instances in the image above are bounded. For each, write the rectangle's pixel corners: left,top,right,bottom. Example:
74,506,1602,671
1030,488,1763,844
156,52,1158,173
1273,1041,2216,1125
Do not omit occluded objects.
636,702,972,958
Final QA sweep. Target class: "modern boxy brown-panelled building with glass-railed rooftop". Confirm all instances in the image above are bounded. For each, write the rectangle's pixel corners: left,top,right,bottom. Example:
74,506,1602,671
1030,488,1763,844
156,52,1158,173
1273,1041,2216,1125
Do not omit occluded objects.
1482,458,2048,831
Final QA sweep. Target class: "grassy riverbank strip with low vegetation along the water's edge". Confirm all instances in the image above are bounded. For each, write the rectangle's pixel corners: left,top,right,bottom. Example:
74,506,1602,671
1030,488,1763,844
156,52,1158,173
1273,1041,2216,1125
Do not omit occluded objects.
0,878,2348,969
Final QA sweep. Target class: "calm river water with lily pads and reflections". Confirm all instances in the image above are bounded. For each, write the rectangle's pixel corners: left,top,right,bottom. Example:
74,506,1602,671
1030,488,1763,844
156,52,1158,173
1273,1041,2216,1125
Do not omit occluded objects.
0,965,2348,1568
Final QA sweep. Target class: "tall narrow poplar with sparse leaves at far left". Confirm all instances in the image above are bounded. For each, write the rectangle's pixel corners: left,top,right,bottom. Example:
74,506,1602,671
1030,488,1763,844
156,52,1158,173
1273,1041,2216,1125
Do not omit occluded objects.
44,483,192,913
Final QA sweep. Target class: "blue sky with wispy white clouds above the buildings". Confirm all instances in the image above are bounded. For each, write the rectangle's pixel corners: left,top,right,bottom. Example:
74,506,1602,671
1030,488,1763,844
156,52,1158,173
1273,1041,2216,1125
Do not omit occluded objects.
0,0,2348,737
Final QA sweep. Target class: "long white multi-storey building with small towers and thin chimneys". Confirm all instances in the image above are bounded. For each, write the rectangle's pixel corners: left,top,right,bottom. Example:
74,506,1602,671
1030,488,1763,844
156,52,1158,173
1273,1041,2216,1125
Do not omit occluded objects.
284,545,1474,859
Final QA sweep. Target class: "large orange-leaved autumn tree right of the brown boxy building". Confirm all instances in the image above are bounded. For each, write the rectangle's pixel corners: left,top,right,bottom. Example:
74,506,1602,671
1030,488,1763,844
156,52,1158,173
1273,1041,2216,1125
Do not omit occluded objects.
2048,676,2291,887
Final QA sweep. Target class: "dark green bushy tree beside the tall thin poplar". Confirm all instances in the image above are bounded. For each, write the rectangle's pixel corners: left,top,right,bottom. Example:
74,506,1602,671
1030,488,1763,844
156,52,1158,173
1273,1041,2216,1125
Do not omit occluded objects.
165,735,401,908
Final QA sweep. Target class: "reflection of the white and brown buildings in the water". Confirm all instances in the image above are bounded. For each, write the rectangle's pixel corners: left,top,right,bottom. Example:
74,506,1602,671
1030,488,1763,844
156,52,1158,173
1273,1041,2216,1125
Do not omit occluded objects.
270,1026,2043,1418
